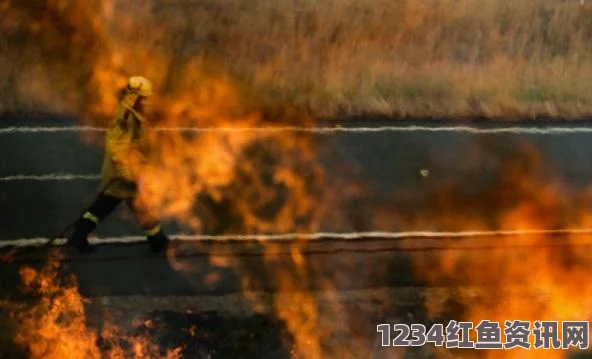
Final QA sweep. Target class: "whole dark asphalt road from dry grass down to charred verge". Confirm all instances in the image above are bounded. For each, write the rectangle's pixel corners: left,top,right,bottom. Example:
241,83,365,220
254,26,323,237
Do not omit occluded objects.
0,114,592,296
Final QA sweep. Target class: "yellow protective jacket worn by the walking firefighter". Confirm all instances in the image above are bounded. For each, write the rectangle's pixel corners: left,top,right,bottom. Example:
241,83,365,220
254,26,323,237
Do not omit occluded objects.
101,97,148,199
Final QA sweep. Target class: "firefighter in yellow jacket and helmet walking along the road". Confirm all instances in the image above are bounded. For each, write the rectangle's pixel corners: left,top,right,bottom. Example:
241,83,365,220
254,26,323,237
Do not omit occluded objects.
68,76,169,253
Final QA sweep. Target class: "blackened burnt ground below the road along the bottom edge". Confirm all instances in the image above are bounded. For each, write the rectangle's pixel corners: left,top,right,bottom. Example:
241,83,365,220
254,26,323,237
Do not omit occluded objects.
0,287,592,359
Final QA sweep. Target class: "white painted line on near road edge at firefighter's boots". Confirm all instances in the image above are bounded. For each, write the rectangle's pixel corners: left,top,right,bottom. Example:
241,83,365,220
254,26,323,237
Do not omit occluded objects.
0,228,592,248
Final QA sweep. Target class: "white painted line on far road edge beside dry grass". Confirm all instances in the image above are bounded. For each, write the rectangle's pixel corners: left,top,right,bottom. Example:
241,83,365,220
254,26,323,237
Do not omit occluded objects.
0,126,592,135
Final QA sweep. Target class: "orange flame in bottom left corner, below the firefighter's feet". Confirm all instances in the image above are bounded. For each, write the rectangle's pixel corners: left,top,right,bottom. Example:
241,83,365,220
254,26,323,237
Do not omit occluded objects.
6,251,181,359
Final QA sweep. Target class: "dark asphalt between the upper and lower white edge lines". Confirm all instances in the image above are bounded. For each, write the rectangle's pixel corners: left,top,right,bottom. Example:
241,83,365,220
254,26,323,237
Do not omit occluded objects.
0,118,592,241
